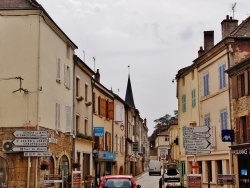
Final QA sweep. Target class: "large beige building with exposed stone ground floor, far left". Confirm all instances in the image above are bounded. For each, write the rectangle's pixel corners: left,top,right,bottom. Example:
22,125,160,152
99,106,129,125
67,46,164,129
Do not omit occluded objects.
0,0,77,188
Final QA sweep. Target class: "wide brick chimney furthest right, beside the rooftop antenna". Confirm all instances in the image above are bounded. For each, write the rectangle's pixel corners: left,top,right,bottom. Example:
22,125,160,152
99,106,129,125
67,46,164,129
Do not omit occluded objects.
221,15,238,39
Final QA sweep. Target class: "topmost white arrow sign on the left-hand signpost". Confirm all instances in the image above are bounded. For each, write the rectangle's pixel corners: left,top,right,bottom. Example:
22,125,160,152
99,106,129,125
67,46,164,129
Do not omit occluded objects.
12,130,48,138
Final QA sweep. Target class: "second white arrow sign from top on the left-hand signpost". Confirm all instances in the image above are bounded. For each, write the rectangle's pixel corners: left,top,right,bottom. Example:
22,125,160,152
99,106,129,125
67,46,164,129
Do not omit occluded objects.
13,138,48,146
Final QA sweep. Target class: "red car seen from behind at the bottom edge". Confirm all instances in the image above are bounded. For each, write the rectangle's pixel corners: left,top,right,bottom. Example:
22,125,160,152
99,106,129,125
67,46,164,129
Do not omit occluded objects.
99,175,141,188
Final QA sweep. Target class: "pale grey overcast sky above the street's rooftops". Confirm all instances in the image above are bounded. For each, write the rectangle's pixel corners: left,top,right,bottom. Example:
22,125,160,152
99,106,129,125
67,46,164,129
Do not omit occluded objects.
37,0,250,136
